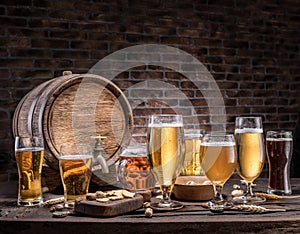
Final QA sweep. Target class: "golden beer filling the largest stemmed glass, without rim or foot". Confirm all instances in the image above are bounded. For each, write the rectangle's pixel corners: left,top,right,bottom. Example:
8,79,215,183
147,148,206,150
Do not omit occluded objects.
148,125,184,193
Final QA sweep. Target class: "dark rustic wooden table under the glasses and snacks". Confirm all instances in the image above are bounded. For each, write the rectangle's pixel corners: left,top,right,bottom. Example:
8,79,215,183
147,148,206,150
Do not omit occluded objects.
0,179,300,234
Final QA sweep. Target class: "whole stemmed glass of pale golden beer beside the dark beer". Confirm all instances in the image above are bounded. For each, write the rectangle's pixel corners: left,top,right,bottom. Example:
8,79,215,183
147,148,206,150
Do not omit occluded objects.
234,117,266,204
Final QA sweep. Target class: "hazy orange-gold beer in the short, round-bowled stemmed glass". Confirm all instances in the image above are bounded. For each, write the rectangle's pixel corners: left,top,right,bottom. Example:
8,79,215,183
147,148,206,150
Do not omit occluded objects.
200,142,237,186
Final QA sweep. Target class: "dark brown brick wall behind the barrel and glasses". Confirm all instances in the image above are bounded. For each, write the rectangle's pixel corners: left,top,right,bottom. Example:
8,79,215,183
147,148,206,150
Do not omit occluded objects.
0,0,300,180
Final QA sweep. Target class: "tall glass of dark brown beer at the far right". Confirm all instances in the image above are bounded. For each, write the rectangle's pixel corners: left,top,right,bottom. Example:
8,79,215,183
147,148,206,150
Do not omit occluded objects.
266,130,293,195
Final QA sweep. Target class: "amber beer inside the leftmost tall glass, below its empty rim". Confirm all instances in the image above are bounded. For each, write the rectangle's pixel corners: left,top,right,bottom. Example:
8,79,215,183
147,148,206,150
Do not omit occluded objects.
16,148,44,205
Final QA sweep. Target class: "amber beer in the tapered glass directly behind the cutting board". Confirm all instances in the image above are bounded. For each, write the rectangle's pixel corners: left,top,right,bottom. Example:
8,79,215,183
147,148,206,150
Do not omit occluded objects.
59,155,92,207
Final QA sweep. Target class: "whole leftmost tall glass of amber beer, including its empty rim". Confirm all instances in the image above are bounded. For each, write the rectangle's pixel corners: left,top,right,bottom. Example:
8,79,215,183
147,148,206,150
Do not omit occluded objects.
15,136,44,206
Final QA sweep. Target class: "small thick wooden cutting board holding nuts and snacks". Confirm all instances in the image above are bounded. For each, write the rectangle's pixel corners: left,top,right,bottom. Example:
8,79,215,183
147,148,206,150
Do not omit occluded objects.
75,194,143,217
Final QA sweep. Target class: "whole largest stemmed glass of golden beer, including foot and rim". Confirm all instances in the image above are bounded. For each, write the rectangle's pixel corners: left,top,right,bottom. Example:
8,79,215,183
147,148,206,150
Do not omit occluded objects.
147,115,185,210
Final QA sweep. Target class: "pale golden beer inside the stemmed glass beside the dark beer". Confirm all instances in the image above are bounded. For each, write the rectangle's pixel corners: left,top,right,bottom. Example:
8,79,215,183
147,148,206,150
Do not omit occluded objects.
235,129,265,183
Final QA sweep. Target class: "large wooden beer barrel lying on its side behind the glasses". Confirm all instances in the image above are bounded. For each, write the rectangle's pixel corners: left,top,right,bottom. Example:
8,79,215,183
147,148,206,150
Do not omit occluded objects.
13,74,133,192
